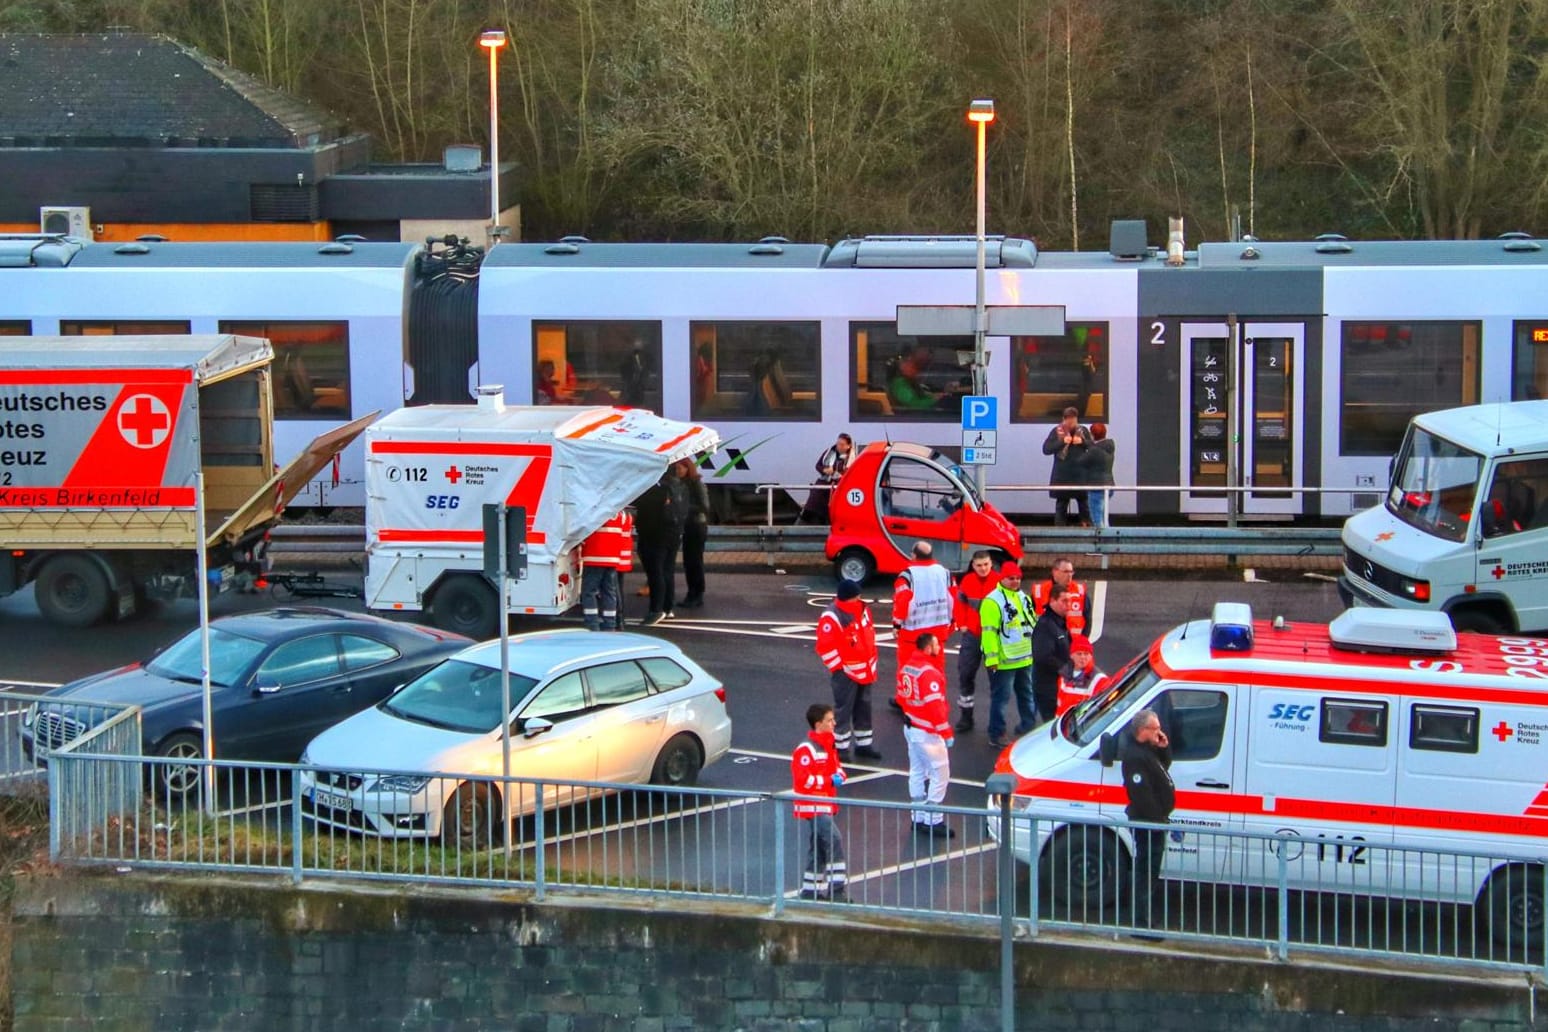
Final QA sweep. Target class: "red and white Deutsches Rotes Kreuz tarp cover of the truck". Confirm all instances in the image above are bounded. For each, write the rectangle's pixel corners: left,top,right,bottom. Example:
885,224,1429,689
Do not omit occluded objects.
0,334,272,509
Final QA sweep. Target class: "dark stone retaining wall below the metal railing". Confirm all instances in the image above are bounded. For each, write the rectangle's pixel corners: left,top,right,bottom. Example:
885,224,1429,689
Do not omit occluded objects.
9,874,1548,1032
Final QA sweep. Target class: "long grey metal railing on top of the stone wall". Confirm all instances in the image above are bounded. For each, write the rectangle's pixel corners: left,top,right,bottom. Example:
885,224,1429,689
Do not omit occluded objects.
36,749,1548,975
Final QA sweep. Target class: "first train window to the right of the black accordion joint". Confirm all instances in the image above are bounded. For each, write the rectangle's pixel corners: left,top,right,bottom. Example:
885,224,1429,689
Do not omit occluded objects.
533,319,661,412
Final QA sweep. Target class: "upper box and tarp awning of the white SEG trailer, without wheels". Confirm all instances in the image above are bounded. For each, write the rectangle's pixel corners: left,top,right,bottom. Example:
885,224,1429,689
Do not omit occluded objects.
365,405,720,562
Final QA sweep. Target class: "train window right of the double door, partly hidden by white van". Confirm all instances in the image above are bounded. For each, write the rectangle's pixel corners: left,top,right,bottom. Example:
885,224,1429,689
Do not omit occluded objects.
1339,322,1481,455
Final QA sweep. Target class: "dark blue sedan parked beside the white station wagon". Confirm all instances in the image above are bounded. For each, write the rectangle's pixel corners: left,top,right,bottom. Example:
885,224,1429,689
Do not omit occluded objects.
22,607,471,795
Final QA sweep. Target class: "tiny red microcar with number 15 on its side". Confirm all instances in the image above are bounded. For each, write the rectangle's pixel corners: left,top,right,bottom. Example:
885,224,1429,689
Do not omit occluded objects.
827,441,1022,583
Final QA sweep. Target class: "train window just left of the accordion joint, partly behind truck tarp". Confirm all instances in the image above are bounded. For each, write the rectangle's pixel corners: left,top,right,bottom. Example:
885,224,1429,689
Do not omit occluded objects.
220,319,350,419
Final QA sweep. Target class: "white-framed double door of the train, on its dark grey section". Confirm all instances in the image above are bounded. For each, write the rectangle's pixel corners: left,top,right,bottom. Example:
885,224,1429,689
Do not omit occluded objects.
1178,322,1307,515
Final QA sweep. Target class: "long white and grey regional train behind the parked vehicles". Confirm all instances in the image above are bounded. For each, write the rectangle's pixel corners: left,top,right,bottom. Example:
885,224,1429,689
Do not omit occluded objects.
0,224,1548,520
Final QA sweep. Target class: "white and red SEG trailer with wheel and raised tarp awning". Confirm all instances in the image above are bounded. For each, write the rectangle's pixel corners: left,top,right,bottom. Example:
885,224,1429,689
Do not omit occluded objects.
365,385,720,637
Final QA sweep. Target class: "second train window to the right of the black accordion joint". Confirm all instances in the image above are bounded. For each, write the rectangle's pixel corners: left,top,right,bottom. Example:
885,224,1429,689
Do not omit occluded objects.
689,322,822,419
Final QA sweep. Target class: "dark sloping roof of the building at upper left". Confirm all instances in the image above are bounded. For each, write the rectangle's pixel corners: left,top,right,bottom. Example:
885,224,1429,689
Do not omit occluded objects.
0,32,342,149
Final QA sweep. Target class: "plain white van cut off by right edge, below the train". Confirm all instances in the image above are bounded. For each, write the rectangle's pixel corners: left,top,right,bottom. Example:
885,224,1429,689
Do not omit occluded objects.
1339,401,1548,634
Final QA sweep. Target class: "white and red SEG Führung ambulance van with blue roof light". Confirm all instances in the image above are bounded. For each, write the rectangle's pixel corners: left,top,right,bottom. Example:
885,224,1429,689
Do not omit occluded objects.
989,603,1548,944
